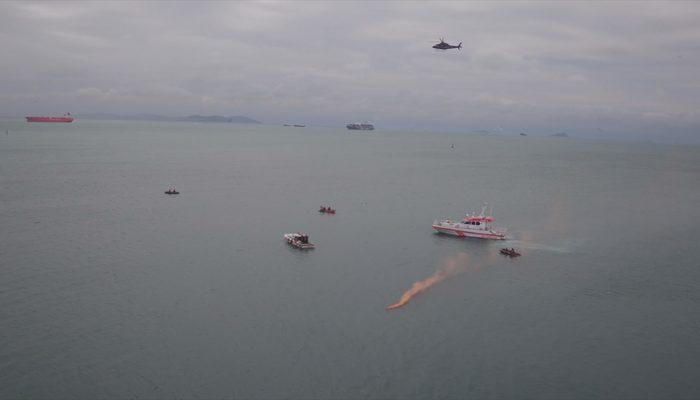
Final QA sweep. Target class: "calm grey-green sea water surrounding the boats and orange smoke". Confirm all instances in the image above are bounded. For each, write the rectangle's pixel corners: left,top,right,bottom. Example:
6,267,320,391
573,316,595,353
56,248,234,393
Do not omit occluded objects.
0,120,700,399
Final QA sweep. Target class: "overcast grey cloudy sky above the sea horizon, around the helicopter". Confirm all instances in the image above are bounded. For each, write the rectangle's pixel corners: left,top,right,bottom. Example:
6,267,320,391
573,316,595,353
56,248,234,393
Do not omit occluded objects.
0,1,700,143
